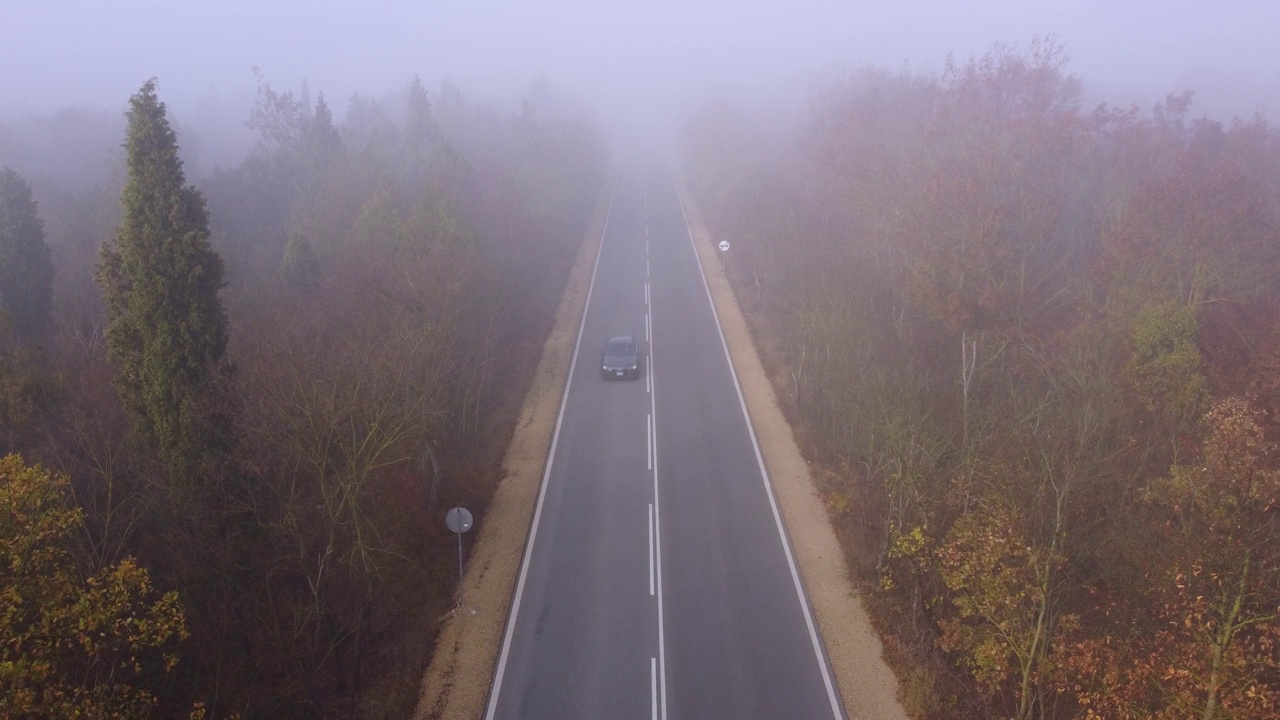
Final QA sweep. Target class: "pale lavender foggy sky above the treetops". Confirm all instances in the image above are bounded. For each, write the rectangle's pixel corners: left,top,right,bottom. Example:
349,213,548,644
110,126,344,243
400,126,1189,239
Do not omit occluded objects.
0,0,1280,118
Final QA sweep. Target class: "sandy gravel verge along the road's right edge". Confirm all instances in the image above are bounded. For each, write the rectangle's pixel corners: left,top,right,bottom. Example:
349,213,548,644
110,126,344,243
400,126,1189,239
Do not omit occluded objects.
677,183,909,720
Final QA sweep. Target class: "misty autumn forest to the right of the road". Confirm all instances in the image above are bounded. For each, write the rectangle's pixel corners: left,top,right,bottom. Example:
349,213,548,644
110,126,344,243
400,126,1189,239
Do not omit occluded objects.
680,40,1280,720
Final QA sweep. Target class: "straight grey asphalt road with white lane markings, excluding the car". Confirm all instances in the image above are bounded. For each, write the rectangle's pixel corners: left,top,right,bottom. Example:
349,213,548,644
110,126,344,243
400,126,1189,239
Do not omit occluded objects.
485,165,844,720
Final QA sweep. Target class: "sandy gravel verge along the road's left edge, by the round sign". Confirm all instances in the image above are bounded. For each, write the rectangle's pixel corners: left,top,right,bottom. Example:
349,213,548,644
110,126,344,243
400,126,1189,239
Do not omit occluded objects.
413,183,612,720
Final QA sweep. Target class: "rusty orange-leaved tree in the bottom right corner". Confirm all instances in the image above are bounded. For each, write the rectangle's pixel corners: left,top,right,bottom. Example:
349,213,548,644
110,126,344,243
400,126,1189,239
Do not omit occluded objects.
1064,397,1280,720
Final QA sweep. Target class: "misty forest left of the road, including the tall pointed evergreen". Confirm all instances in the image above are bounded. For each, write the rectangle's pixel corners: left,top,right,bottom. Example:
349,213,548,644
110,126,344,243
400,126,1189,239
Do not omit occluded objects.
0,74,608,719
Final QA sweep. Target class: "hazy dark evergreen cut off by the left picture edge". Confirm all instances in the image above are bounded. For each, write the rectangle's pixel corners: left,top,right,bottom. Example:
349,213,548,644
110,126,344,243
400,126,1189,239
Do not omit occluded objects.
0,168,54,337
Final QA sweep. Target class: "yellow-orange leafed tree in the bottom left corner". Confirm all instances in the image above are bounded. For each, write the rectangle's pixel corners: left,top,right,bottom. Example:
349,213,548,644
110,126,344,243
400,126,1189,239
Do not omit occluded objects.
0,455,187,719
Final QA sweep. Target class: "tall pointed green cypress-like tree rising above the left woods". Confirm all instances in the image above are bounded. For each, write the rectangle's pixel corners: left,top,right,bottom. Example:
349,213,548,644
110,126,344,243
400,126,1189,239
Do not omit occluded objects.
97,78,227,478
